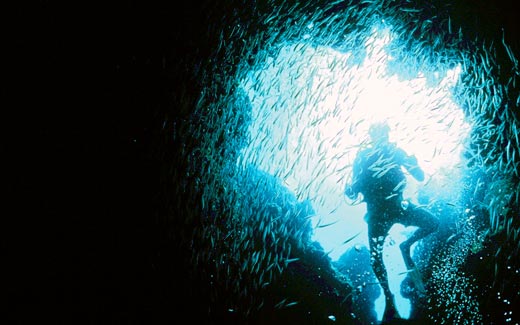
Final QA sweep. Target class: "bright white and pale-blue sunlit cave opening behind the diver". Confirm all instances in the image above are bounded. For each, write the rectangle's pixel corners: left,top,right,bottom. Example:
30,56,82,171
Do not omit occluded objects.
239,22,471,317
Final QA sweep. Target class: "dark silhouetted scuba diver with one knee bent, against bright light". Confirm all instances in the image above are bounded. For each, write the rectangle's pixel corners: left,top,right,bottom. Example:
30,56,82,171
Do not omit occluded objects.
345,123,439,321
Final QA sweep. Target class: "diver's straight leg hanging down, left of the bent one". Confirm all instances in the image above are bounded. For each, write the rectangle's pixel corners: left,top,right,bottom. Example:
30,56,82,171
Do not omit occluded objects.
368,220,400,320
